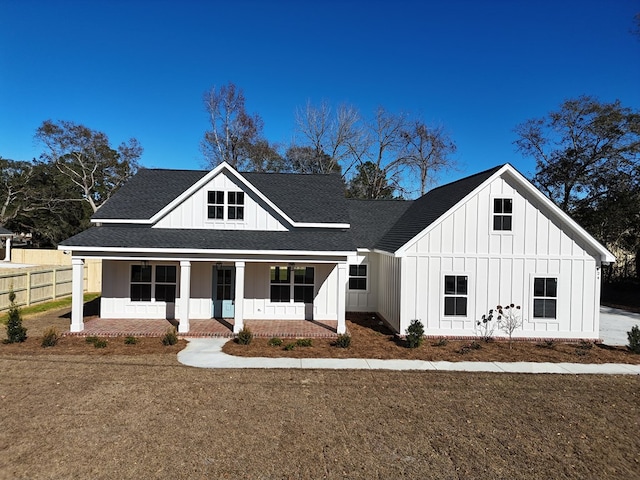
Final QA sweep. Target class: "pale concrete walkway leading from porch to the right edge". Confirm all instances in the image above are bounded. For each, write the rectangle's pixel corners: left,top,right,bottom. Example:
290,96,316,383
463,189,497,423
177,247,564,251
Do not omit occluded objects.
178,338,640,375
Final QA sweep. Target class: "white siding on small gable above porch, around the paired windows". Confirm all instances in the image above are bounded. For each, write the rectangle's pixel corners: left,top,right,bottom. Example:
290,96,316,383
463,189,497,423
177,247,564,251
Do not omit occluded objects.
154,171,287,231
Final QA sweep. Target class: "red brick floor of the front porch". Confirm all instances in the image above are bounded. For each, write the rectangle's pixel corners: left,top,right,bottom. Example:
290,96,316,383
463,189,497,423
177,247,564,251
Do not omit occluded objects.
67,318,338,338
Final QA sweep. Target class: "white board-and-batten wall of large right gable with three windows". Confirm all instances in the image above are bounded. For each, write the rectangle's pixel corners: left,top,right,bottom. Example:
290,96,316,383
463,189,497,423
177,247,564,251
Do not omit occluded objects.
399,177,600,338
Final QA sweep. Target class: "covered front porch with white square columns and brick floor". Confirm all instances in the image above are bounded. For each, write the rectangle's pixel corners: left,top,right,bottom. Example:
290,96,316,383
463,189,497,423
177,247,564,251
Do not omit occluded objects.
70,253,347,337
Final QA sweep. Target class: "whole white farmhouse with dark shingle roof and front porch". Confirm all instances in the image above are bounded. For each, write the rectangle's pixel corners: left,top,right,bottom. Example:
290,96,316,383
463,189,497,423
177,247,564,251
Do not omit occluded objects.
59,163,615,339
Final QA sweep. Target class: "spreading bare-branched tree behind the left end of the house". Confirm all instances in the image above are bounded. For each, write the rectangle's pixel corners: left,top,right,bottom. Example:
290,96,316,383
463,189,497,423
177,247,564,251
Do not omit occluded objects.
35,120,142,212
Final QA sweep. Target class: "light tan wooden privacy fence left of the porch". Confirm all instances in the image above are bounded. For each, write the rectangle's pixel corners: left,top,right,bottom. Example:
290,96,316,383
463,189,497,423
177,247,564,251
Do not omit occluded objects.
0,266,87,311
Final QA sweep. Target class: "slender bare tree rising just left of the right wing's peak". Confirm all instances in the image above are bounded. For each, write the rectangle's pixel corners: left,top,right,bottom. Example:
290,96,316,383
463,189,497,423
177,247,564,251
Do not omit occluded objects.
400,120,456,195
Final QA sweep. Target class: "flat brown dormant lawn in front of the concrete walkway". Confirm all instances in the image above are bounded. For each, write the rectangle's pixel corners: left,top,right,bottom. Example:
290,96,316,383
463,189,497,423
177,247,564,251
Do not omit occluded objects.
0,352,640,479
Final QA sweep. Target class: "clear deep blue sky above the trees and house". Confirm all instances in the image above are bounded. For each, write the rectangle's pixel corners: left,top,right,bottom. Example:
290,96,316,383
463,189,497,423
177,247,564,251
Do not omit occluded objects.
0,0,640,185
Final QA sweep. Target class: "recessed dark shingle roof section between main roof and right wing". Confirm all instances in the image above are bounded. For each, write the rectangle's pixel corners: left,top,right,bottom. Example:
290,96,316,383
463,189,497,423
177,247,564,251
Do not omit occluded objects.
347,198,413,248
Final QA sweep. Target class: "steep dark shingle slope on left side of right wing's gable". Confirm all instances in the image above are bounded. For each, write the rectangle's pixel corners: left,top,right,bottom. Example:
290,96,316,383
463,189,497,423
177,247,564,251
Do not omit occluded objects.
376,165,503,252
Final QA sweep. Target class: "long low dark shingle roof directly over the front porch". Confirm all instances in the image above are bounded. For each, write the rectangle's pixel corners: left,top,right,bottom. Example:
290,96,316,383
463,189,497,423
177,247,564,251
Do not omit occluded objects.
60,226,355,252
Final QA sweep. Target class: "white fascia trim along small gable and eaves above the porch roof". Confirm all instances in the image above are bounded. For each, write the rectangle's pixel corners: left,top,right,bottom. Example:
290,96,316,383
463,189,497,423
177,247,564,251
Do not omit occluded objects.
91,162,350,228
